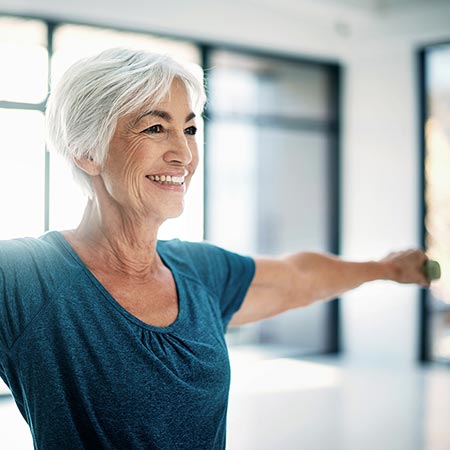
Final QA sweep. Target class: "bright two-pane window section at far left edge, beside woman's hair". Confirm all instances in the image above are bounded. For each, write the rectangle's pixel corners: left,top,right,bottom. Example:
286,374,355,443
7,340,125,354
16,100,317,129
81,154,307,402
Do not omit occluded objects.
0,17,48,239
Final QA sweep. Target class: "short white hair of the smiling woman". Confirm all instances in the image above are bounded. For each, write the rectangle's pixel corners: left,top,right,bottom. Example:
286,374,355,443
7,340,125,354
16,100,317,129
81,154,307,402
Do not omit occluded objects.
46,48,205,197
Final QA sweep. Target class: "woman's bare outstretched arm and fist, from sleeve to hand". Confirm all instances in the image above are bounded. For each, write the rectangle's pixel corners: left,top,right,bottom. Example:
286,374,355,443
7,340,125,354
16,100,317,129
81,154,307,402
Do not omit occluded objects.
230,249,430,326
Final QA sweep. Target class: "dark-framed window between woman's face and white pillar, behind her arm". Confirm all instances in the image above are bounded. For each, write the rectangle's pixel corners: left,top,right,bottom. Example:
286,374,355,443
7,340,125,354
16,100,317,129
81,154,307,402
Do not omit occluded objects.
206,50,338,353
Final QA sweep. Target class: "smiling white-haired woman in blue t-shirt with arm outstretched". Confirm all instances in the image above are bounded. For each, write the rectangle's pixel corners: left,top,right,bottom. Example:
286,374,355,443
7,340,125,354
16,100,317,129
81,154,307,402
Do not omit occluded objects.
0,49,429,450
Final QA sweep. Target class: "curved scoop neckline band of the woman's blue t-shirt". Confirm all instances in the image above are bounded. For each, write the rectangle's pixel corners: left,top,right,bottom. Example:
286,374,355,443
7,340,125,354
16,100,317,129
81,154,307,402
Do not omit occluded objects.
48,231,184,333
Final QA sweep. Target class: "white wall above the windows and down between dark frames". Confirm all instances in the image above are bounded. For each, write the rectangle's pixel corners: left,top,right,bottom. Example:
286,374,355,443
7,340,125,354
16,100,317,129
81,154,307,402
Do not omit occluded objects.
0,0,450,364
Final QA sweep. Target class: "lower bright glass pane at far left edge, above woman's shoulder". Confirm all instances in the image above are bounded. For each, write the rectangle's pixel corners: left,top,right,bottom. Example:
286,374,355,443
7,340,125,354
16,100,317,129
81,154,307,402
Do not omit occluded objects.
0,109,45,239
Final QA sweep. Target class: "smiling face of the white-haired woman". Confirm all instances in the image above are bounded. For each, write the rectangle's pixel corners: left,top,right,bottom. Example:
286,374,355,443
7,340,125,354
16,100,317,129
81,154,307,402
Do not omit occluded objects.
99,81,198,223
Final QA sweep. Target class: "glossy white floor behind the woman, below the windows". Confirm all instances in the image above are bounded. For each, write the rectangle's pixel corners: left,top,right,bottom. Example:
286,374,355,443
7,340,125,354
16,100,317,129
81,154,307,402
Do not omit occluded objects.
0,347,450,450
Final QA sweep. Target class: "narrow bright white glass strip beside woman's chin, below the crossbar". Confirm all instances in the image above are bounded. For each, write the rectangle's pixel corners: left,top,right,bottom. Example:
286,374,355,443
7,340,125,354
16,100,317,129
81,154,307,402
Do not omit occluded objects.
207,120,258,254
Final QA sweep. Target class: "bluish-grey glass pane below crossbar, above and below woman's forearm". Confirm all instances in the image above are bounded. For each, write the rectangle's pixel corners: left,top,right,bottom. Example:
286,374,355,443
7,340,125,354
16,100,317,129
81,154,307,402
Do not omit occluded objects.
253,128,332,354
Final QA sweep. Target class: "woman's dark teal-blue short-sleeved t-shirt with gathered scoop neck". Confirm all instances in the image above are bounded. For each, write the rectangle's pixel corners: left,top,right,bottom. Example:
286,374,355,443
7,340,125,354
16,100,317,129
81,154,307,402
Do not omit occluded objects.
0,232,255,450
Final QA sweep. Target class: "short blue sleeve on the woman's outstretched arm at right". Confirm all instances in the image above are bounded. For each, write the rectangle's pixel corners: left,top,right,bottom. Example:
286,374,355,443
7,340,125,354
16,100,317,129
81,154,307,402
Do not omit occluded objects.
159,241,255,330
